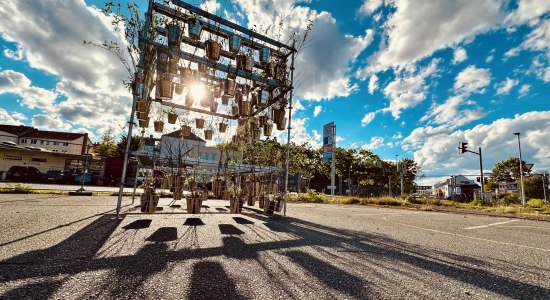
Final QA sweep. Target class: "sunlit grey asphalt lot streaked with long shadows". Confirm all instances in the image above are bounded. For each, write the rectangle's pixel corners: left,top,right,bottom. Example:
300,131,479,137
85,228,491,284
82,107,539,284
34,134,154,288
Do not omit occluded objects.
0,195,550,300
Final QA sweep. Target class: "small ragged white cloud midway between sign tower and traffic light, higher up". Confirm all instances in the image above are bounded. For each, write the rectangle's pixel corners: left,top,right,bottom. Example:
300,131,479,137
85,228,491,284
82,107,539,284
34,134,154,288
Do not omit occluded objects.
382,59,439,119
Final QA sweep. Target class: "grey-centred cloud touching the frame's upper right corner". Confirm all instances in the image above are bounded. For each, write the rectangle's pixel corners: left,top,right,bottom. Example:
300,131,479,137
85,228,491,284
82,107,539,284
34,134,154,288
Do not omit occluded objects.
235,0,373,101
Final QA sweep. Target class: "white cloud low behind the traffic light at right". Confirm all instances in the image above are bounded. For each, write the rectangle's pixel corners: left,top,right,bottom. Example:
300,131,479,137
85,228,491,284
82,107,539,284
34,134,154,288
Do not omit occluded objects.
403,111,550,174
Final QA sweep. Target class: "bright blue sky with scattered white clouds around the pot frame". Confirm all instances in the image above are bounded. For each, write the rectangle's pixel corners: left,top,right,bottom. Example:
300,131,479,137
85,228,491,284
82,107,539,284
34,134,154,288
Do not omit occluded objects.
0,0,550,183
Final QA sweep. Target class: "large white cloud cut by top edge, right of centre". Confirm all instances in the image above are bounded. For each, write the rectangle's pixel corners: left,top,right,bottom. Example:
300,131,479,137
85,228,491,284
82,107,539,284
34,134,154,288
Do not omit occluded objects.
370,0,505,69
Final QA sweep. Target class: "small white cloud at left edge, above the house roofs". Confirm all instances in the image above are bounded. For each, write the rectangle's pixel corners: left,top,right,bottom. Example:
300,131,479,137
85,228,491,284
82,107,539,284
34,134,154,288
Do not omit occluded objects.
0,70,57,109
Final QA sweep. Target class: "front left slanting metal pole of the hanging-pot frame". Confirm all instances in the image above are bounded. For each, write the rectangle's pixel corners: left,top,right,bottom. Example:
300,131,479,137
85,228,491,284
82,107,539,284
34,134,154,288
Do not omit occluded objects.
116,0,153,219
